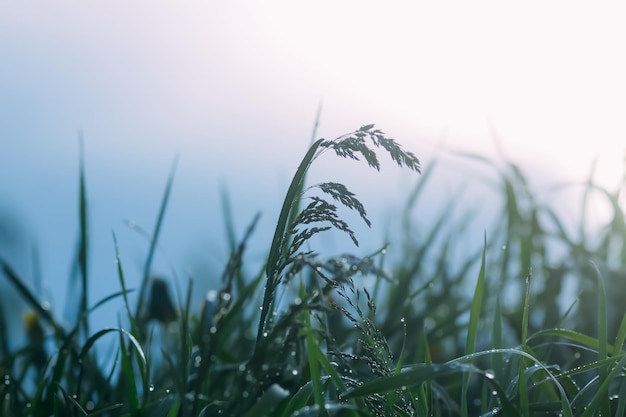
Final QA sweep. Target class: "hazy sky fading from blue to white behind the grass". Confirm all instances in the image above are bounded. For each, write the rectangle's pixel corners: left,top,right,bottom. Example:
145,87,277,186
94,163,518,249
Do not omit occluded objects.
0,0,626,334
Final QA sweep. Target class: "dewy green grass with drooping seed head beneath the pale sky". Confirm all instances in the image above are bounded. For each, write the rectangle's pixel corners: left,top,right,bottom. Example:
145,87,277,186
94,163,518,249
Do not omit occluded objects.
0,125,626,417
